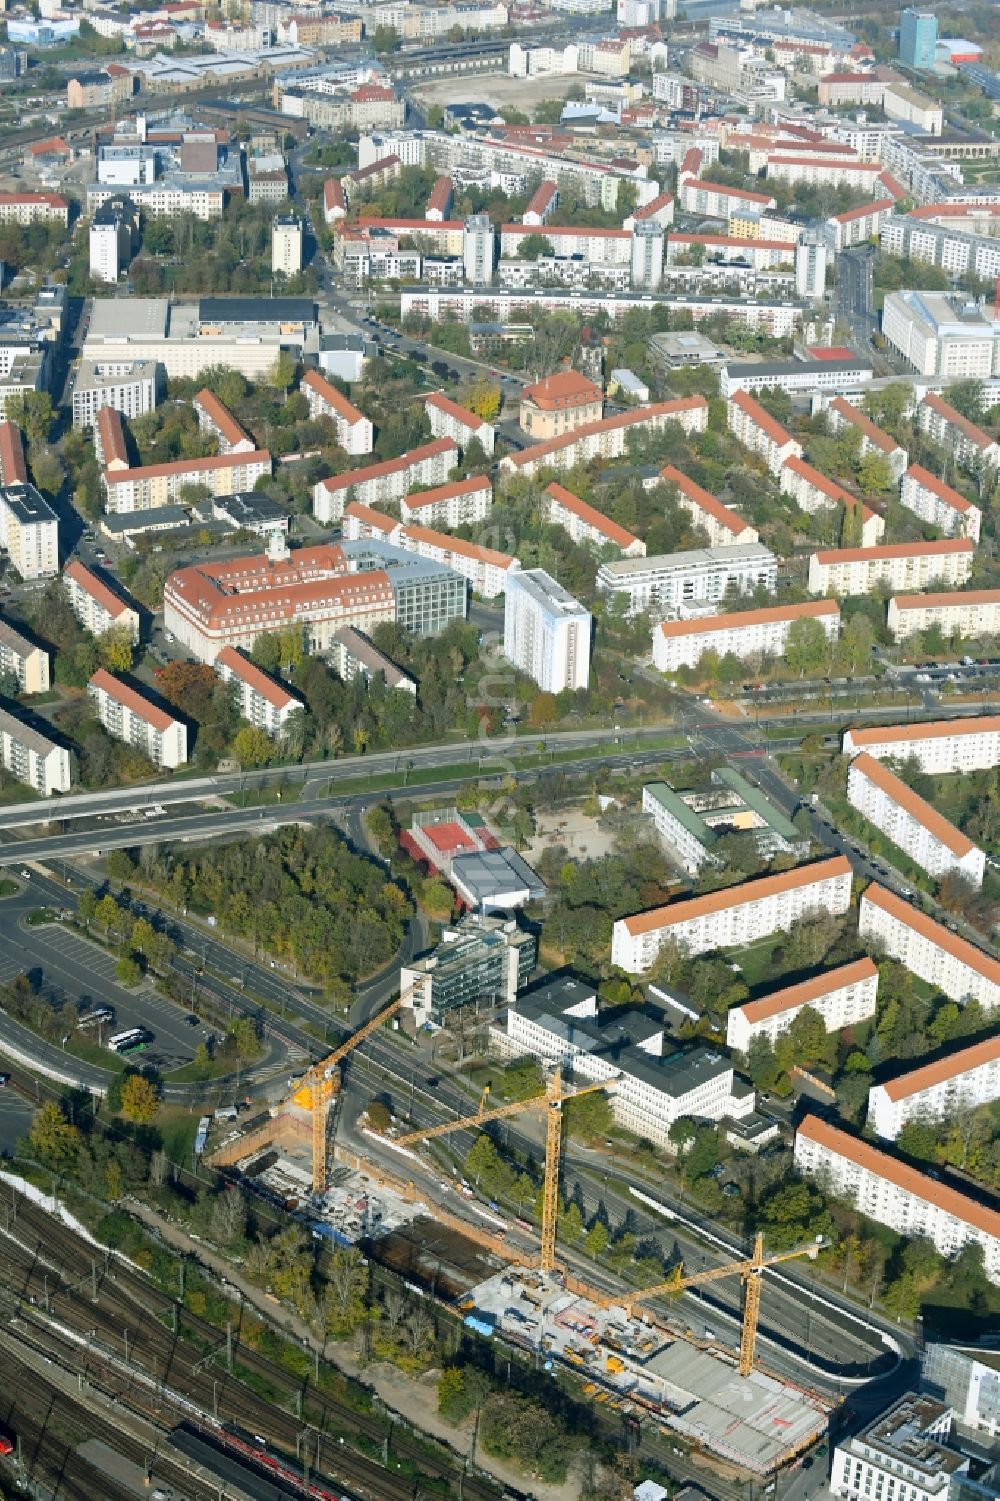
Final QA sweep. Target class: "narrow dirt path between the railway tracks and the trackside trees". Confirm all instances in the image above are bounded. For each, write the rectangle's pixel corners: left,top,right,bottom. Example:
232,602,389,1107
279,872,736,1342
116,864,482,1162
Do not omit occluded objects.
128,1199,580,1501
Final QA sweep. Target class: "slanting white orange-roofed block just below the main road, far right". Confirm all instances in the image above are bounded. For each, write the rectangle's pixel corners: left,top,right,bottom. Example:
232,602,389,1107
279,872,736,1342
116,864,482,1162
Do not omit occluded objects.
847,752,986,886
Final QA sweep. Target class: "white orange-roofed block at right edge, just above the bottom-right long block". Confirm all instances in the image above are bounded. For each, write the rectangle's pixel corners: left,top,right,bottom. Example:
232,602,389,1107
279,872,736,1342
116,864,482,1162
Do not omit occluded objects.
868,1036,1000,1141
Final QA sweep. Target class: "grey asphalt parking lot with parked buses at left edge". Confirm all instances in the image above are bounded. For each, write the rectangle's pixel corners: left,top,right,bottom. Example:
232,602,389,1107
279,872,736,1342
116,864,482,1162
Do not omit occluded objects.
0,923,215,1072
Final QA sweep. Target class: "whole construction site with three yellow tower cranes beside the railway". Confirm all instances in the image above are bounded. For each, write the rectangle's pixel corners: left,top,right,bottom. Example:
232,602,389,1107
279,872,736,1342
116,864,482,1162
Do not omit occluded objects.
209,1000,832,1477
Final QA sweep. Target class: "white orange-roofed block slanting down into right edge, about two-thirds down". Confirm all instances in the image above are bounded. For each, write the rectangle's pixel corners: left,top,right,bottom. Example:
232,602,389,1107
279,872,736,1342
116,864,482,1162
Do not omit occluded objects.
857,883,1000,1012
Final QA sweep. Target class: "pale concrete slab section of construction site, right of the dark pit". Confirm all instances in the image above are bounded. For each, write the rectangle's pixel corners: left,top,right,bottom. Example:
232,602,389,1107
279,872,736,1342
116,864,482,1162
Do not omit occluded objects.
459,1267,832,1475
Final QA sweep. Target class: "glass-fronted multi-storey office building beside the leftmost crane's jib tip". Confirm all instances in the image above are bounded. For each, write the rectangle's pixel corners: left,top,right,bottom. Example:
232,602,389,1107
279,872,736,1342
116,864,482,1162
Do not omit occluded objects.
399,913,538,1028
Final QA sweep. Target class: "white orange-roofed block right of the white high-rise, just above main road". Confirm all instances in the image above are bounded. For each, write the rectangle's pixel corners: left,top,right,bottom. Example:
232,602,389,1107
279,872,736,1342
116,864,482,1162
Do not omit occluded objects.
653,599,841,672
